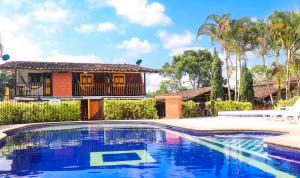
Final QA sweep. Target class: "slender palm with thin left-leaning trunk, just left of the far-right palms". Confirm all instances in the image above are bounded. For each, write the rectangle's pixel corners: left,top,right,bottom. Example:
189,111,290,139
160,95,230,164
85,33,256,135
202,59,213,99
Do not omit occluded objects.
252,21,274,105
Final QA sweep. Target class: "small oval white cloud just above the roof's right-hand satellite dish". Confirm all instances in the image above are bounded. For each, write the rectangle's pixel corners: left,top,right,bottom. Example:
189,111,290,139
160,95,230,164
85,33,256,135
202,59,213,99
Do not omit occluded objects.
117,37,158,55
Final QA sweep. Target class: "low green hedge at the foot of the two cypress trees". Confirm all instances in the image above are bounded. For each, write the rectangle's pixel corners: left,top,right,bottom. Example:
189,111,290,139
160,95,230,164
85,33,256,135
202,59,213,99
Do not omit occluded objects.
205,101,253,112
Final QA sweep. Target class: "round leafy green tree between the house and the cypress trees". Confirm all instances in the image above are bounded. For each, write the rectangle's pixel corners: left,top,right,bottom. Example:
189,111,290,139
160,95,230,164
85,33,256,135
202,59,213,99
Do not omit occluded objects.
161,50,212,92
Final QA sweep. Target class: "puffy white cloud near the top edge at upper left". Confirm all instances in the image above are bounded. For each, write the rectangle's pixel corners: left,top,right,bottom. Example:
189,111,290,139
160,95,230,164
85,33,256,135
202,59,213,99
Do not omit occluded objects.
33,1,70,22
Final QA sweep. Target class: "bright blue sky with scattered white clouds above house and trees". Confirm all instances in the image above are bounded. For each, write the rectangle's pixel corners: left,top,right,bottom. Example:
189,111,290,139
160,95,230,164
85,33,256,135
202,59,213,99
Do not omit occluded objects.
0,0,300,90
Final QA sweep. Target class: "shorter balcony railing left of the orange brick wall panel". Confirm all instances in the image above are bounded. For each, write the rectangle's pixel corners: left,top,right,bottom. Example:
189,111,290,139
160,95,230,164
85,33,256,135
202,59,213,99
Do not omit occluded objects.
14,83,51,97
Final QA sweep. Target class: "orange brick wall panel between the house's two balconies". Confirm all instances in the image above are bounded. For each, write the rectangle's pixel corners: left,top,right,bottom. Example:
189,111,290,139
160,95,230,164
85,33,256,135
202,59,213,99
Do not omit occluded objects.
52,72,72,96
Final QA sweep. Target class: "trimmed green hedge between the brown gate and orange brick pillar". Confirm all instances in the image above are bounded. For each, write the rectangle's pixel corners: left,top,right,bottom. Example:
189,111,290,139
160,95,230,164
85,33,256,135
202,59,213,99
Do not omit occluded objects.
104,98,158,120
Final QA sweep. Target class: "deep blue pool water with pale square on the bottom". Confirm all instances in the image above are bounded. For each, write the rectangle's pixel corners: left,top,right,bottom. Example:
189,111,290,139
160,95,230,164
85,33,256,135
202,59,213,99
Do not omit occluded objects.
0,125,300,178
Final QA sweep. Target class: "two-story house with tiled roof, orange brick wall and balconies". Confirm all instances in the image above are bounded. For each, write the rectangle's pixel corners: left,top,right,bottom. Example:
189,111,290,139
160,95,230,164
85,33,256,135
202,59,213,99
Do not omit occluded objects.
0,61,157,119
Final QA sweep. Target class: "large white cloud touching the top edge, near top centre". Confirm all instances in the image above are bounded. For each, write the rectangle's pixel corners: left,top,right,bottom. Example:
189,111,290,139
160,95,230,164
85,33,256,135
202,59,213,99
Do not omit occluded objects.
106,0,171,26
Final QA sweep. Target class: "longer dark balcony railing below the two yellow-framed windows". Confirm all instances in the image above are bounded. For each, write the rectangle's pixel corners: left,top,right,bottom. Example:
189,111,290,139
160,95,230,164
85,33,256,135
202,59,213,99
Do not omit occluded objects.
73,83,145,96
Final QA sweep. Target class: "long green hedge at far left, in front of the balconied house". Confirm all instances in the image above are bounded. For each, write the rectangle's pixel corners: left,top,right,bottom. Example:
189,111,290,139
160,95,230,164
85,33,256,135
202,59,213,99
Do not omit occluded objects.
0,101,81,124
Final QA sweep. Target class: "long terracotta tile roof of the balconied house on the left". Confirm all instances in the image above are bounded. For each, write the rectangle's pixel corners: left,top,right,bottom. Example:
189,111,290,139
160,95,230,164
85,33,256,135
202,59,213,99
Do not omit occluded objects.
0,61,158,73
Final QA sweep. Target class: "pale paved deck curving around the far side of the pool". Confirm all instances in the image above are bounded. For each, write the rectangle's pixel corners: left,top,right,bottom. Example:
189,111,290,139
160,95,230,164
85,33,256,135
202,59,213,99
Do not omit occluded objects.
0,117,300,151
